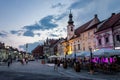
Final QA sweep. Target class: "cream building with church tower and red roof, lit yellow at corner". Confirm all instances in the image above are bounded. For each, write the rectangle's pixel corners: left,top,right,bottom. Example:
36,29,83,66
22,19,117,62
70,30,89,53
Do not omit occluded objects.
63,13,100,54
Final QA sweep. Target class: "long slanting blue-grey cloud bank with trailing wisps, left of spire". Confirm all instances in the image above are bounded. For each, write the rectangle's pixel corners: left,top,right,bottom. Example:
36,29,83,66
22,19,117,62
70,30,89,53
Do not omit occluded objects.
10,13,66,37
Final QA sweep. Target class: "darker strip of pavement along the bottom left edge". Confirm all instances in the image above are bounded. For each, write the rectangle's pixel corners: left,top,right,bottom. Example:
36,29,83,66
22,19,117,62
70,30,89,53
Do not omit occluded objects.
0,71,92,80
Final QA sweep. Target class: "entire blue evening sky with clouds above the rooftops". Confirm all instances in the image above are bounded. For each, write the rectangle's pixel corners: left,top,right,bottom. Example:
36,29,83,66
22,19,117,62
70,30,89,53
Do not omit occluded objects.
0,0,120,50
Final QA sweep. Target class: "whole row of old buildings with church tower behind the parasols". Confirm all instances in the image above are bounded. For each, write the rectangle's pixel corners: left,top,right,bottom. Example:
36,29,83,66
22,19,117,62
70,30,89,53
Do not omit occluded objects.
43,12,120,56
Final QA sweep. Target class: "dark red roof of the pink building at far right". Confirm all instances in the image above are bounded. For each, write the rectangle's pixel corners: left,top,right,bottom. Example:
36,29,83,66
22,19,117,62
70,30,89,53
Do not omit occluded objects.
97,13,120,32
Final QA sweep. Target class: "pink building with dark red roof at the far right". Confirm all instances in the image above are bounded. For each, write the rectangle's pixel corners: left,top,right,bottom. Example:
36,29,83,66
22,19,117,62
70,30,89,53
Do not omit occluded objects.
95,13,120,49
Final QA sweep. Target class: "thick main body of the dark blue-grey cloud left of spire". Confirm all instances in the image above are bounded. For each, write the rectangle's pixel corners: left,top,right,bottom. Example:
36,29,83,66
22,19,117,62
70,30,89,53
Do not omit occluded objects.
23,15,58,31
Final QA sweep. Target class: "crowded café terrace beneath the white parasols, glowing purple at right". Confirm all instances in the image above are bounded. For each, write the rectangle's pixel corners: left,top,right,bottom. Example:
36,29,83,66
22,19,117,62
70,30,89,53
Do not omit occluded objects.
48,57,120,72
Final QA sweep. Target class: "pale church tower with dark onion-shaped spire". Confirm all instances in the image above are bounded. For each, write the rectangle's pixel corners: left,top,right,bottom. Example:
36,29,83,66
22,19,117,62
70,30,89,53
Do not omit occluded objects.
67,10,74,40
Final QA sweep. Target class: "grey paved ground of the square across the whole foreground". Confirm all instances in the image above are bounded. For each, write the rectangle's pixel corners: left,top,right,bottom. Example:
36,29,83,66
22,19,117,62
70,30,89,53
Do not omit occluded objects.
0,61,120,80
